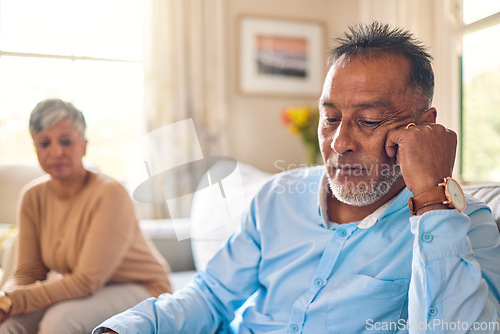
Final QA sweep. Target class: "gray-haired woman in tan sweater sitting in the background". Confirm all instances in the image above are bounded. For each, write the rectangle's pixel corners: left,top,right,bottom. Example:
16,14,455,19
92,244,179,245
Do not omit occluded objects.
0,99,171,334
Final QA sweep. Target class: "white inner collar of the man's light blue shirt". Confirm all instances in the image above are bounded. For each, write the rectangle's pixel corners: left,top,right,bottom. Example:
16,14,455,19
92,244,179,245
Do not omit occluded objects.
318,171,404,229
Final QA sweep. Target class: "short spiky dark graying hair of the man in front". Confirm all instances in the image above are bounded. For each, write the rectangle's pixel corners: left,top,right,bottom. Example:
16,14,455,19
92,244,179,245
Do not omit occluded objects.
328,21,434,106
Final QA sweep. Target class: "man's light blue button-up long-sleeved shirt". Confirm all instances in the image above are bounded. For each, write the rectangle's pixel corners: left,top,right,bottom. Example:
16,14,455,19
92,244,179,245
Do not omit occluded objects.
95,166,500,334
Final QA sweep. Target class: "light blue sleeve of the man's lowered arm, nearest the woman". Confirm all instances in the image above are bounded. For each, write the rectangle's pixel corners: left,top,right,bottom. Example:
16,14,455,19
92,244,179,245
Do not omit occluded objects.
93,201,260,334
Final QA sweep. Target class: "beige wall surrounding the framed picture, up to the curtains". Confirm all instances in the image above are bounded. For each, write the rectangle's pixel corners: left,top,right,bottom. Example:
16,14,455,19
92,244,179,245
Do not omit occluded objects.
226,0,357,172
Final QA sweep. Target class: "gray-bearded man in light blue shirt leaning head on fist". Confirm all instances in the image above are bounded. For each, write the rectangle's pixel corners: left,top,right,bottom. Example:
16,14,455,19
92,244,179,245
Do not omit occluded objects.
95,22,500,334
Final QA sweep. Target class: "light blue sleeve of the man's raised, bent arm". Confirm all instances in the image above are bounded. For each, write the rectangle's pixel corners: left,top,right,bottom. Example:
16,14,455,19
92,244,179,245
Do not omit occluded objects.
408,206,500,333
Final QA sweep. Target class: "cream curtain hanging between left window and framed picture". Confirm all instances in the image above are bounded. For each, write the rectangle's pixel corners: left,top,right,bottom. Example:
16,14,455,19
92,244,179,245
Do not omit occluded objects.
140,0,227,217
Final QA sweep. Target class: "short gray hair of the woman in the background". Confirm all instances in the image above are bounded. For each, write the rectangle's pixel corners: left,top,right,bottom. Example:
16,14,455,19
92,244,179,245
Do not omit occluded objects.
30,99,87,138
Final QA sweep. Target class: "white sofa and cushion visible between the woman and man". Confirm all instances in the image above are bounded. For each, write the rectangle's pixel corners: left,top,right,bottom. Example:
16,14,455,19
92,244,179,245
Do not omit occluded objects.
140,161,271,290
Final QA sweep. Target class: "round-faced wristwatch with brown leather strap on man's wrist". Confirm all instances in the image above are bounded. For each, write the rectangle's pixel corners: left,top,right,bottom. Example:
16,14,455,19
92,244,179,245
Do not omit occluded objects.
408,177,466,215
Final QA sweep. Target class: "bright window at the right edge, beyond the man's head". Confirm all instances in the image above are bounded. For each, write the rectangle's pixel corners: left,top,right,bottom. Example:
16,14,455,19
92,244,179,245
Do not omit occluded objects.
461,0,500,182
